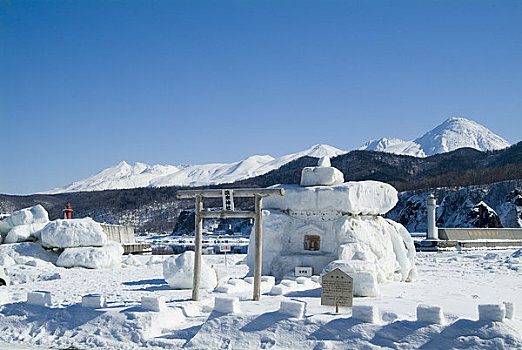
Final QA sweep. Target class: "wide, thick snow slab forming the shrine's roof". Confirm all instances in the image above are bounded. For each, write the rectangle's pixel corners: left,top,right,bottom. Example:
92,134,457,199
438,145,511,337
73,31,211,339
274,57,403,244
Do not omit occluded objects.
263,181,398,215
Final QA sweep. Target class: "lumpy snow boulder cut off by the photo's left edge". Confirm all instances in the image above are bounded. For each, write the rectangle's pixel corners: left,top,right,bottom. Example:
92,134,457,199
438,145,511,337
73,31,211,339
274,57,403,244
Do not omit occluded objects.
0,204,49,243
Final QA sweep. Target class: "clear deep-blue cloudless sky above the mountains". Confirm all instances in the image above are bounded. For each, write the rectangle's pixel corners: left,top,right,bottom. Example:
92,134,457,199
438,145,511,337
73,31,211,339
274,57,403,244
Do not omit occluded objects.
0,0,522,194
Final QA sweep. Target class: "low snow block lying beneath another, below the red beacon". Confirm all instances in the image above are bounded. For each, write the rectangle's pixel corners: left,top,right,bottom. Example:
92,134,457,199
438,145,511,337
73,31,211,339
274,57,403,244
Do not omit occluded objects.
56,241,123,269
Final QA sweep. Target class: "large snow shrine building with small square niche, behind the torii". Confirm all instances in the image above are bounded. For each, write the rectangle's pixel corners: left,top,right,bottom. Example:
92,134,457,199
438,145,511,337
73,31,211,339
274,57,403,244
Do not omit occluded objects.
247,157,416,296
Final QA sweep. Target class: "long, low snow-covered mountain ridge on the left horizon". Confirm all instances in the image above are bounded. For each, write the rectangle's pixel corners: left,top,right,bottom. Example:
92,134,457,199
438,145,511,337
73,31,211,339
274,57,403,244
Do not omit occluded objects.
45,145,346,194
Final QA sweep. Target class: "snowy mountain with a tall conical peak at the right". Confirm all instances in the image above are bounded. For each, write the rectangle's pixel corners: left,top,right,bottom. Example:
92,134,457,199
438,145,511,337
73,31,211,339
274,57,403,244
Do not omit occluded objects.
358,118,510,157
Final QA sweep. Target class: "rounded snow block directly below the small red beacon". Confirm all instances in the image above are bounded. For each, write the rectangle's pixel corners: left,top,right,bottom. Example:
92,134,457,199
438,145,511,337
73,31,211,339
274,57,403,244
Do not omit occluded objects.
41,218,107,248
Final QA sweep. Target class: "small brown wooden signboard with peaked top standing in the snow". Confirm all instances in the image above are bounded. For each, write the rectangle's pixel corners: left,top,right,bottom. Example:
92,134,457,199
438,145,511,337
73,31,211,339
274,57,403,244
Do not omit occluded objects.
321,269,353,307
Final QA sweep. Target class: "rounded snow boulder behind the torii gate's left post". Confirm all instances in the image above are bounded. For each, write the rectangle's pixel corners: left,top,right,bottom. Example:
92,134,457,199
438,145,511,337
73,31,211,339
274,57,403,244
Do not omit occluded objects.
163,251,217,289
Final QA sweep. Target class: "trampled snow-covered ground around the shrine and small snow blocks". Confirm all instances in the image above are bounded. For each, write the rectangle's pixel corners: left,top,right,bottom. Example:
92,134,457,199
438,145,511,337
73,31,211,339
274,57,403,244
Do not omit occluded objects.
0,249,522,349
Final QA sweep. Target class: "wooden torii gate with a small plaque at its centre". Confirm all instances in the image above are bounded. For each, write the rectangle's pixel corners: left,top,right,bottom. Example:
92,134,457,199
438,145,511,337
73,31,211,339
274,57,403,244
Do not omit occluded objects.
177,188,285,301
